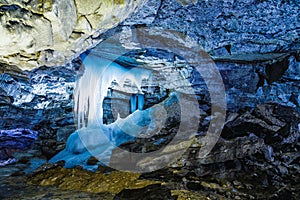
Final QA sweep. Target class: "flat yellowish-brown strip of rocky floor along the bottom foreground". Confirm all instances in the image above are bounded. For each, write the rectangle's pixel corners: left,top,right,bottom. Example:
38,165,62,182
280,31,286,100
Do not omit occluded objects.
0,162,254,199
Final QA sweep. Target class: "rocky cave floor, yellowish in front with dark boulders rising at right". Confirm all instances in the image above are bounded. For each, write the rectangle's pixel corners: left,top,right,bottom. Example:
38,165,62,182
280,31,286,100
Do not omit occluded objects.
0,104,300,200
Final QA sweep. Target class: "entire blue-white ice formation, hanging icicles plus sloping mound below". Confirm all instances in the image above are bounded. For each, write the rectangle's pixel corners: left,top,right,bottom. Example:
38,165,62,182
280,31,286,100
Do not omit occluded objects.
50,54,156,168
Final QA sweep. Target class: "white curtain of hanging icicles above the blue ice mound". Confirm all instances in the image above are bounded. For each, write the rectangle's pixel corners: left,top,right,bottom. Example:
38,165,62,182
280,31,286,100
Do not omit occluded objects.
74,55,151,128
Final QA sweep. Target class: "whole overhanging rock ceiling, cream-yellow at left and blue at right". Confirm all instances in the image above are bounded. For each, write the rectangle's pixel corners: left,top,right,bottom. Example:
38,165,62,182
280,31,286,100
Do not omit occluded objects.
0,0,299,69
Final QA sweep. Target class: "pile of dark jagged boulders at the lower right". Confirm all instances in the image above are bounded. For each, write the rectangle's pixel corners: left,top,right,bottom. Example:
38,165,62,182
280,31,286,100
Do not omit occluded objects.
109,103,300,199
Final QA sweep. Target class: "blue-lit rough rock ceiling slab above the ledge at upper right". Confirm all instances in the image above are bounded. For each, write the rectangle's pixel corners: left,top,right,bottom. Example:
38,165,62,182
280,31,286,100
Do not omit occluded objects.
154,0,299,60
